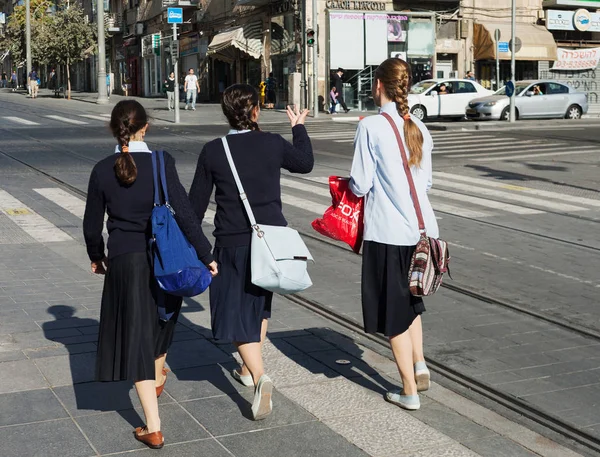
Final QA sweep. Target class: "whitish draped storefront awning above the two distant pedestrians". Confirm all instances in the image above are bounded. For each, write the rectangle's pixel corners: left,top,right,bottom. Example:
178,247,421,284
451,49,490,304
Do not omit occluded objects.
207,21,263,60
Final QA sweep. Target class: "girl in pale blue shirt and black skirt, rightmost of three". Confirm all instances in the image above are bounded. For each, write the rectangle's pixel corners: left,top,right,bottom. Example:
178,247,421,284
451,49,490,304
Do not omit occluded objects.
350,59,439,410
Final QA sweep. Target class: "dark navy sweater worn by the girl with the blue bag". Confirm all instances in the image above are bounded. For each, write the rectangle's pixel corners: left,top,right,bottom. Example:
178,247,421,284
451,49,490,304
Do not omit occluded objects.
83,152,213,265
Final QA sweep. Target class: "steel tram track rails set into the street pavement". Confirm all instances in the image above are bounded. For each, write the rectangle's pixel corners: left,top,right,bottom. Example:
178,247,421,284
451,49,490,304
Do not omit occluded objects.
0,146,600,453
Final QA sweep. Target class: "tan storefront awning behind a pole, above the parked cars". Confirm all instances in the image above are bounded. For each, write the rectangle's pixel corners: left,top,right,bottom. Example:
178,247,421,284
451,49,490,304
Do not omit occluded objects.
473,22,556,61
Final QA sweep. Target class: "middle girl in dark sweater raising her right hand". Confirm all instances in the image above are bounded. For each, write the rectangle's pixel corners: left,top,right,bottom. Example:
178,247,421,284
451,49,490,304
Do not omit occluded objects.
190,84,314,420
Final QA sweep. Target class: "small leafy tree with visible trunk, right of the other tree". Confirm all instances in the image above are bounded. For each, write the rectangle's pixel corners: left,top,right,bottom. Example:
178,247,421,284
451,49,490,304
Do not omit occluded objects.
40,1,96,99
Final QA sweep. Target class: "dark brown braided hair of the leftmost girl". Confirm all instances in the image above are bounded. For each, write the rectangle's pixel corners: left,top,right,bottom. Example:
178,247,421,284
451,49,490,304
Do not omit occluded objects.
110,100,148,186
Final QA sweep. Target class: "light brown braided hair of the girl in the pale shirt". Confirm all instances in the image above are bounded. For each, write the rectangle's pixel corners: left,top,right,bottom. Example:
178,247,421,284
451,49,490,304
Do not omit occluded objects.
375,58,423,167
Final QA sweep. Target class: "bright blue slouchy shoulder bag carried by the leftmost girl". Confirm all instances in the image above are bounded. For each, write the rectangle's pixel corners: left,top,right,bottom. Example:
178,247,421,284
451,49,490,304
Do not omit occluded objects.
150,151,212,297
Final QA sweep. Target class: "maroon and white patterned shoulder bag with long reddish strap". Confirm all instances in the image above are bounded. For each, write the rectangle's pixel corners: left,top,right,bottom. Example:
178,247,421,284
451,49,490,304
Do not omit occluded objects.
382,113,450,297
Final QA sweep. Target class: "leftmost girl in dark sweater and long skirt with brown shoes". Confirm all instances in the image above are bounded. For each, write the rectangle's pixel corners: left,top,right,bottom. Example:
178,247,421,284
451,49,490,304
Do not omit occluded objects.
83,100,217,449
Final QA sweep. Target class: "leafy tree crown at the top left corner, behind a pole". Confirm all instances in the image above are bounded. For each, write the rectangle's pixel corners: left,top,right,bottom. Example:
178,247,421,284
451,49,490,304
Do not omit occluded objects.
0,0,53,66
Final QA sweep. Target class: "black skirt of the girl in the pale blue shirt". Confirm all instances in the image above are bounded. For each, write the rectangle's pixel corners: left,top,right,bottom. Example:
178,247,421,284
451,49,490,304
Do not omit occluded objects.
361,241,425,336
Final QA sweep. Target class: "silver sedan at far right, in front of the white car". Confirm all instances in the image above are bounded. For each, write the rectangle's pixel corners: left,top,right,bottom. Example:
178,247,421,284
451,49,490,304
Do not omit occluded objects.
466,80,588,120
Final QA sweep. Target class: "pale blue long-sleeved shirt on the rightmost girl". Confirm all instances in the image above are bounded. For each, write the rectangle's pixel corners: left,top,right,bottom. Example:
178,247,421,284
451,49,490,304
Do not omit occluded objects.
350,102,439,246
